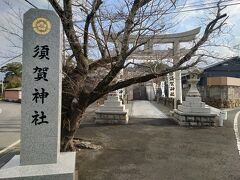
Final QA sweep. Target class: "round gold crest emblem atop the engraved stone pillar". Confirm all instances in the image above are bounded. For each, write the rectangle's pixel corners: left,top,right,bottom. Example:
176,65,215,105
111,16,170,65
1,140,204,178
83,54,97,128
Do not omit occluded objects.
32,17,52,35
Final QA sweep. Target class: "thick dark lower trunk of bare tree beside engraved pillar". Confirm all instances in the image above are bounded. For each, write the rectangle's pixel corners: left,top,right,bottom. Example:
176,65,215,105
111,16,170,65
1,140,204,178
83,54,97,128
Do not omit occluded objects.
61,72,88,152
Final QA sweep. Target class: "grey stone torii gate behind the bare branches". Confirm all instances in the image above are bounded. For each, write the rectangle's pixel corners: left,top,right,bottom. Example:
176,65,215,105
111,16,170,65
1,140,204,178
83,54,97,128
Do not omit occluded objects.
105,27,201,108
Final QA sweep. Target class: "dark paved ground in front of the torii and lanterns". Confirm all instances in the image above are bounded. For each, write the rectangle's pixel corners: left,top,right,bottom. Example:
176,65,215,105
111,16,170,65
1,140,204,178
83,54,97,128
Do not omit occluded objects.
77,101,240,180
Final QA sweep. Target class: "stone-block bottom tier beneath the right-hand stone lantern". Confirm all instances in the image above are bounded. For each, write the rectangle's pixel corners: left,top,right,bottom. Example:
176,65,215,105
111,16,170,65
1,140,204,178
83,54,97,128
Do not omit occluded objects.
172,109,217,127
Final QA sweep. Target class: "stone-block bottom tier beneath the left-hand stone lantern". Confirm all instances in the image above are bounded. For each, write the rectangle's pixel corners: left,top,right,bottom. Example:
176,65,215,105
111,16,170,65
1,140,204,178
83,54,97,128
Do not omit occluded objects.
95,110,128,124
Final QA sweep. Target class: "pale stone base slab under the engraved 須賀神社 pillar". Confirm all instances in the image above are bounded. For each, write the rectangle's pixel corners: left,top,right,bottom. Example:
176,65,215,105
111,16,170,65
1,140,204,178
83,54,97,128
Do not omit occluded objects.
0,152,76,180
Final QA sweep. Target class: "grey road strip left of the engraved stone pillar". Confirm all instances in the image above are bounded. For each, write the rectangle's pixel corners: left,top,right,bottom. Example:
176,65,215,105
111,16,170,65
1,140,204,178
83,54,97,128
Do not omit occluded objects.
0,101,21,150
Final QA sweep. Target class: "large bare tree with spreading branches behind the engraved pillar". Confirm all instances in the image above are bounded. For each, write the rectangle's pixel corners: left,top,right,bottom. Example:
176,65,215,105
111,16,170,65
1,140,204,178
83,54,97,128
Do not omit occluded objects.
0,0,228,151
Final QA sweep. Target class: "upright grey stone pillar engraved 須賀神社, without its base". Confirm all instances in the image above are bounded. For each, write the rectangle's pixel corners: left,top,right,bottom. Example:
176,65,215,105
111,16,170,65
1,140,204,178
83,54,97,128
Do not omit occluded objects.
20,10,62,165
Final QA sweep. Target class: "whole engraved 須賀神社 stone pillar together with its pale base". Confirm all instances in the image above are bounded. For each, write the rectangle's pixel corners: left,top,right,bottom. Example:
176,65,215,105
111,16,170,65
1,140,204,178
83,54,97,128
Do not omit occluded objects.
0,9,76,180
